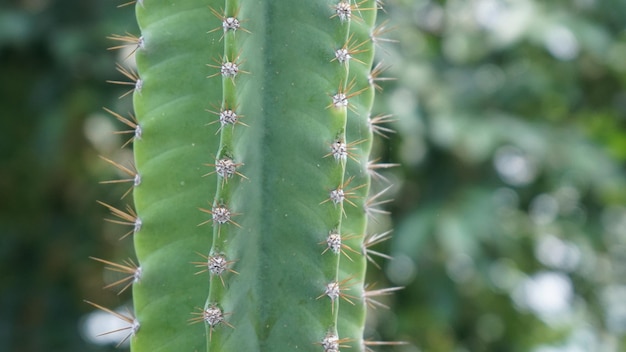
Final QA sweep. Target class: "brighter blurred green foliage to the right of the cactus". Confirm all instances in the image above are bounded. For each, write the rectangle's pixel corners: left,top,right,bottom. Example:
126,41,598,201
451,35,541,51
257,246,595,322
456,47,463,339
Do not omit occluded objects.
370,0,626,352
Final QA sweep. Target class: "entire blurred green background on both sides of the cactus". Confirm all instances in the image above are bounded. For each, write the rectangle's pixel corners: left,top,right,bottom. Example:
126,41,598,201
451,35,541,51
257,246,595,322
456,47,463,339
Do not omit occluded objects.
0,0,626,352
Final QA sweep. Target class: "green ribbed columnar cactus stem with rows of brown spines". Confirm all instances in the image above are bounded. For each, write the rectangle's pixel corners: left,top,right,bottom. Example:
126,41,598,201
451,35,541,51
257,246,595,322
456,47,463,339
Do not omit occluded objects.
89,0,394,351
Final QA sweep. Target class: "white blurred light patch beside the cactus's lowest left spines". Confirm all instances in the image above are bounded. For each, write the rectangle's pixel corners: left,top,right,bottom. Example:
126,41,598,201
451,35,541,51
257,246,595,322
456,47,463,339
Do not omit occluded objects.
80,308,131,347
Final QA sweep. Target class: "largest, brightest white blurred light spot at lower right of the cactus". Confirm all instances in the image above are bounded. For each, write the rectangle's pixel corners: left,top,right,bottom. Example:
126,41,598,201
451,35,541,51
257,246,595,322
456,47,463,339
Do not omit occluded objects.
512,271,574,325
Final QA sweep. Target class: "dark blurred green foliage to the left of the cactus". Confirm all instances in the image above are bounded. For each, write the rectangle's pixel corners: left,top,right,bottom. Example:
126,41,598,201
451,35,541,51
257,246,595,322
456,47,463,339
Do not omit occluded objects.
0,0,136,351
